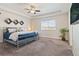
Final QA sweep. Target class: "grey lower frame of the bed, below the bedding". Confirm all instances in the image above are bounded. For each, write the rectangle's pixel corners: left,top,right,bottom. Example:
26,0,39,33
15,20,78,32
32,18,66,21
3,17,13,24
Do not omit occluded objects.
4,34,39,47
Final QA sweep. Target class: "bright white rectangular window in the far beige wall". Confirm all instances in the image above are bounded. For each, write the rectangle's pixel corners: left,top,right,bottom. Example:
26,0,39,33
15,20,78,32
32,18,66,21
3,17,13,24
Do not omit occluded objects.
41,20,56,30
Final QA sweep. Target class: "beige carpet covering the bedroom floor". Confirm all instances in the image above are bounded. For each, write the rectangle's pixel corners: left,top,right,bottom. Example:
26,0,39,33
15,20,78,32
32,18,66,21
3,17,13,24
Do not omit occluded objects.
0,38,73,56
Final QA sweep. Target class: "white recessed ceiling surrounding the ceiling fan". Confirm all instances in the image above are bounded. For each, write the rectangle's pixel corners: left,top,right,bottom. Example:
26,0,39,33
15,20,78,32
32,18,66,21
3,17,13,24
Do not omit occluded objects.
0,3,70,16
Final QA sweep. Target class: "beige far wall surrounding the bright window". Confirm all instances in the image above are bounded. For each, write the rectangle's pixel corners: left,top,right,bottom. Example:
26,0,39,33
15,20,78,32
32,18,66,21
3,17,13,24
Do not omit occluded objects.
31,13,69,39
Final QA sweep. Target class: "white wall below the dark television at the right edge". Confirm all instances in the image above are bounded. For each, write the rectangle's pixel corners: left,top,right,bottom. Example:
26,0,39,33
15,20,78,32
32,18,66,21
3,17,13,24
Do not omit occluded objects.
72,24,79,56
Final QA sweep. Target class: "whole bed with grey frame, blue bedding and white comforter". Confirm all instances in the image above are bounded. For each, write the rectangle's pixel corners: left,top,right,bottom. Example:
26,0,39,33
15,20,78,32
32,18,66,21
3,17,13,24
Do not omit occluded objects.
3,27,39,47
